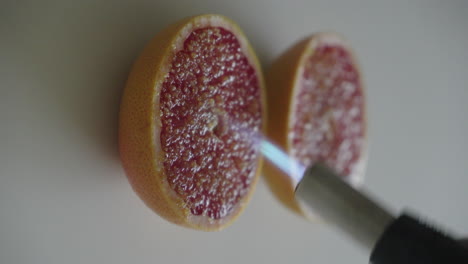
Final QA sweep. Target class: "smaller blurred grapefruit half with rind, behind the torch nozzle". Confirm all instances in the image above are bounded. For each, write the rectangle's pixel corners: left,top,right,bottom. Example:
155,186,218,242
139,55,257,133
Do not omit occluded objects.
265,33,366,217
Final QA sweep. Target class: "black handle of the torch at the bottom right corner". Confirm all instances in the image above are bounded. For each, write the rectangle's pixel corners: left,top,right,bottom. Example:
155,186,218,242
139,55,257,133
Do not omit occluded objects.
370,214,468,264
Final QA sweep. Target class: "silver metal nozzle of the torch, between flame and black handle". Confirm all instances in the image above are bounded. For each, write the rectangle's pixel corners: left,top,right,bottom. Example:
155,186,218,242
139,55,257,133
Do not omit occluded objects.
296,164,394,250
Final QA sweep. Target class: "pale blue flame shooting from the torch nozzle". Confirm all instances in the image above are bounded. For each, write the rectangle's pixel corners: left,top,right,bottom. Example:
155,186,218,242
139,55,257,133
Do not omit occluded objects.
260,139,305,184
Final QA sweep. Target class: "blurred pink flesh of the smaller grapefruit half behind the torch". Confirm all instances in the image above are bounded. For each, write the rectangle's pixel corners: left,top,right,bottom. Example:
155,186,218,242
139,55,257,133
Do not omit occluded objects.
288,43,365,179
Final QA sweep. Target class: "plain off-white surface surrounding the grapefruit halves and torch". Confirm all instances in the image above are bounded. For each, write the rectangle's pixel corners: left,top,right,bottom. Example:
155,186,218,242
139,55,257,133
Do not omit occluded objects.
0,0,468,264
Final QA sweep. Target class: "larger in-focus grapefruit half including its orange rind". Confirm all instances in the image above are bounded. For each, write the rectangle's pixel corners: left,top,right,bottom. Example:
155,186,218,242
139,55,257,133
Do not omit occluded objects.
119,15,266,231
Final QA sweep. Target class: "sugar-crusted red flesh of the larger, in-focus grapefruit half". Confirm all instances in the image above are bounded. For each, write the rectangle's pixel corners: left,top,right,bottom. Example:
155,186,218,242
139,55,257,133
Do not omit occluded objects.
160,27,262,219
